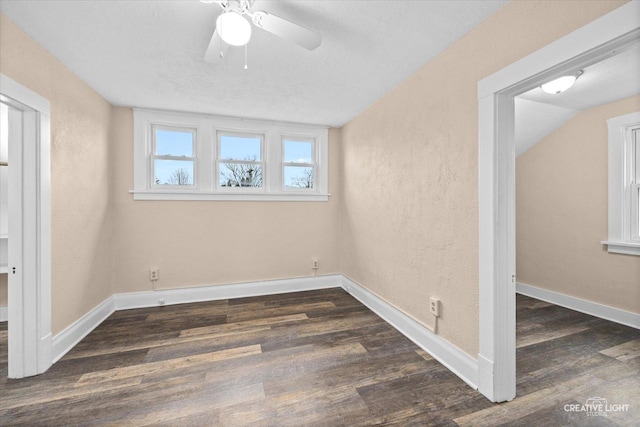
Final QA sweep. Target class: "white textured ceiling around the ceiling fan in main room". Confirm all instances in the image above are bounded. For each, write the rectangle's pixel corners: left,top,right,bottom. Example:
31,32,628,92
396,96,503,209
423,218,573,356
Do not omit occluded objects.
0,0,506,126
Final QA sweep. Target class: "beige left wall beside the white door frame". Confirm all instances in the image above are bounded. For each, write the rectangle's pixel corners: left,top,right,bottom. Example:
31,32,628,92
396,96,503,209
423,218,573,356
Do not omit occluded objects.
0,16,113,334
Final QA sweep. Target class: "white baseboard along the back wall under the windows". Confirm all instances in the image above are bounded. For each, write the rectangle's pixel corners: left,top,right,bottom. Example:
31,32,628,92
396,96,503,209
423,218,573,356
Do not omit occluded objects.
113,274,342,310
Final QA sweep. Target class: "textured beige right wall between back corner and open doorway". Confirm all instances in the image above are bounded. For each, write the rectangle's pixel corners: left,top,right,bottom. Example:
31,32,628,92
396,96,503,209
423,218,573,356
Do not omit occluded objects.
341,1,625,357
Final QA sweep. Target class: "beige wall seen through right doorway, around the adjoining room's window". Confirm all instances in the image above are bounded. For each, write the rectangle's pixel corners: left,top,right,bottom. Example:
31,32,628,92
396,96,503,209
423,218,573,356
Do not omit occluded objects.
516,96,640,313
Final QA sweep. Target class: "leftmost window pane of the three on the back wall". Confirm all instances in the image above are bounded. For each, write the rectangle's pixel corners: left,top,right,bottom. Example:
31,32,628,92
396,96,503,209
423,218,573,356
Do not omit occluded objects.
151,126,196,187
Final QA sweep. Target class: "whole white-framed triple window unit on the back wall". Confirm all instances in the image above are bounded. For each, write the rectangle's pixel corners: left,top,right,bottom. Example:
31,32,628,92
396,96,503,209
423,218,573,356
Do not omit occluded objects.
131,109,329,201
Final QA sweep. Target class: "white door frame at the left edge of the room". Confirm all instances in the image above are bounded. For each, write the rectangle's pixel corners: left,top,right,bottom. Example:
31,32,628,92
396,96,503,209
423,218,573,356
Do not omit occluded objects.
0,74,52,378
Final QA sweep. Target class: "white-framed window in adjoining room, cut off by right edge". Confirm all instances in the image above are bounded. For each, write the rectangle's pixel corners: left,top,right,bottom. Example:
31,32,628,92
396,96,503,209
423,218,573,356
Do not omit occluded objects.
602,112,640,255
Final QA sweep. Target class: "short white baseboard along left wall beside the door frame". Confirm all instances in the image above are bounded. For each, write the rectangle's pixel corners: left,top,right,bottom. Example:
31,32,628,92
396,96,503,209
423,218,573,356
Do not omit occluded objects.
52,296,115,363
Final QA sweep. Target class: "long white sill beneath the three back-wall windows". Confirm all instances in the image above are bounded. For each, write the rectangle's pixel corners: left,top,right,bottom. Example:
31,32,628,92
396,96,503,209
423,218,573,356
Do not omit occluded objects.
129,190,330,202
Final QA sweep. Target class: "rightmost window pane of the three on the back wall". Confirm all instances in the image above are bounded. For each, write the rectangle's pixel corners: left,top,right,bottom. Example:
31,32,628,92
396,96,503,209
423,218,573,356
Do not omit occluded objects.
282,137,316,190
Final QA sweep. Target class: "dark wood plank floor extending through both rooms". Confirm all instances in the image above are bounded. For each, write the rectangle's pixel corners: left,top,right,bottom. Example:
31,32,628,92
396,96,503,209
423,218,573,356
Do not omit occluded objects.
0,289,640,426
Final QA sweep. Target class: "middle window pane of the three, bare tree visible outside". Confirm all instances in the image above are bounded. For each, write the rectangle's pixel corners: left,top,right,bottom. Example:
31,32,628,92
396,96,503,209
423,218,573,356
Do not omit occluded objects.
218,132,264,189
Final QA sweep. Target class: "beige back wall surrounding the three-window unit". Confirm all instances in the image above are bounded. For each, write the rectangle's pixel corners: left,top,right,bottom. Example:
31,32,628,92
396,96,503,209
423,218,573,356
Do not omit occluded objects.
113,108,339,292
